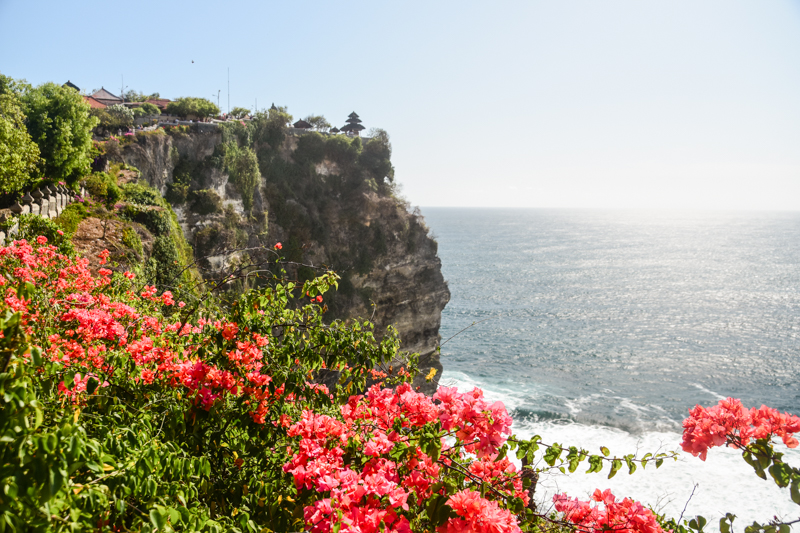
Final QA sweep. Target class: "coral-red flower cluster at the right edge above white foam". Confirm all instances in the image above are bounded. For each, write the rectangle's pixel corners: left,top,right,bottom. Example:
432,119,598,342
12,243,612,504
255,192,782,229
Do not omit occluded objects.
681,398,800,461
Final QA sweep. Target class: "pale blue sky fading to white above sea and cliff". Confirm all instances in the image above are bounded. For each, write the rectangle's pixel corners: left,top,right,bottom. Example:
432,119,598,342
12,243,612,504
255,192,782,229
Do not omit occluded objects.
0,0,800,211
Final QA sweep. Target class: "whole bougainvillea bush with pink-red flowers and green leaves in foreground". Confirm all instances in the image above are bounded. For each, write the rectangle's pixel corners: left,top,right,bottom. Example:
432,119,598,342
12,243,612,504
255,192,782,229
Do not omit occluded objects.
0,237,800,533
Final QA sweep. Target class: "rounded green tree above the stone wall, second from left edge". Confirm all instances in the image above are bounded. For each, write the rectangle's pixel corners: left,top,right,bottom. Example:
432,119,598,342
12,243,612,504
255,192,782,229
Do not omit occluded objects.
21,82,98,181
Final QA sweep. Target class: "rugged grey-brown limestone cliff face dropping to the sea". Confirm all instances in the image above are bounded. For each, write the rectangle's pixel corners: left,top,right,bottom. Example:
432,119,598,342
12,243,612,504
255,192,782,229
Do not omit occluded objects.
122,133,450,393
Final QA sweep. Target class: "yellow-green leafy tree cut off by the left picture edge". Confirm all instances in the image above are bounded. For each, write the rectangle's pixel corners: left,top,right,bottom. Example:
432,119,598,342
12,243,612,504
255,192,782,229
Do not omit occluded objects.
0,92,39,194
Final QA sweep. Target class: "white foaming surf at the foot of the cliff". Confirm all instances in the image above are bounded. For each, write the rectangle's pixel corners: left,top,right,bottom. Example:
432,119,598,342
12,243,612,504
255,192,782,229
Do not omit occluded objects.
442,371,800,530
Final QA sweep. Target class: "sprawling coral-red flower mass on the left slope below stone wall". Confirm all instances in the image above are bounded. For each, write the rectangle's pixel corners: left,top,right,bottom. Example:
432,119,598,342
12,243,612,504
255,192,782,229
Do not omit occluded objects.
0,237,282,418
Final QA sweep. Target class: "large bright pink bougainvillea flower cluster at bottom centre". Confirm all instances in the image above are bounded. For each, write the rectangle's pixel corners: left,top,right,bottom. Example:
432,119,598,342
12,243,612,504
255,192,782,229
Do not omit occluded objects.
284,383,527,533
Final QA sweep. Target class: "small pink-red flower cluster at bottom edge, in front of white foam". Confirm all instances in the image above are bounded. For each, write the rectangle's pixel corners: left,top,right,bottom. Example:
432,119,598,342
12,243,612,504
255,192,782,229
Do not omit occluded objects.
553,489,663,533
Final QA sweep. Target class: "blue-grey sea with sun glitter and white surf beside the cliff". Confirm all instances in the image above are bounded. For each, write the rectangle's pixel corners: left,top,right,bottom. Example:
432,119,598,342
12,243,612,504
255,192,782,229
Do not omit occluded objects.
422,208,800,528
